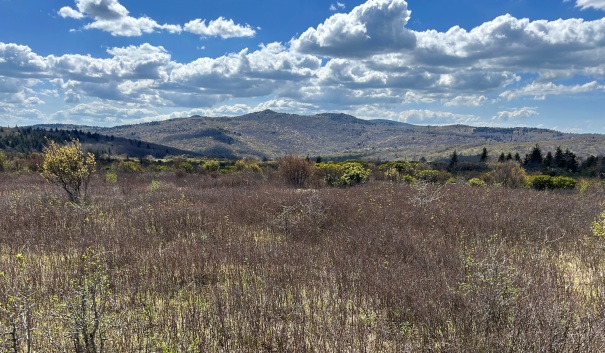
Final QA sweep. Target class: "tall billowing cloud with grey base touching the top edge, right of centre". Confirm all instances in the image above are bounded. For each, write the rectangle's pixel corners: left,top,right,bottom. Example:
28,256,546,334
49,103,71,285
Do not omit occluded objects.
290,0,415,58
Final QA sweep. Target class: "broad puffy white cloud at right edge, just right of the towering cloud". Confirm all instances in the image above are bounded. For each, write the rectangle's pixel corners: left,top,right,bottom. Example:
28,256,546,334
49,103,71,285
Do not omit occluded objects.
412,15,605,72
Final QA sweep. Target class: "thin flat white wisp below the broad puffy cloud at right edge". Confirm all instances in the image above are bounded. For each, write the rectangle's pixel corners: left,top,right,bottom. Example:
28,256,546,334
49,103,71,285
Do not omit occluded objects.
500,81,605,101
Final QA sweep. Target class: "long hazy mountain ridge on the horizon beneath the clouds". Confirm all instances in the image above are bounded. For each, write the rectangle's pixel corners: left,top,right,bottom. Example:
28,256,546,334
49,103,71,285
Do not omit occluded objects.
30,110,605,160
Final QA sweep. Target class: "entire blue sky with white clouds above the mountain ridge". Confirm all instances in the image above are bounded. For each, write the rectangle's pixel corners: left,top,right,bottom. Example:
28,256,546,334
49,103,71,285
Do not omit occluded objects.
0,0,605,133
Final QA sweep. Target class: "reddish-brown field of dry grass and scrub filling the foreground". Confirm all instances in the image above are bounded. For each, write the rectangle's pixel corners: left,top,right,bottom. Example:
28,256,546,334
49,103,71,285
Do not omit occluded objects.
0,173,605,353
